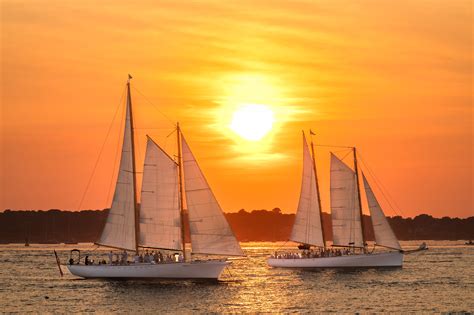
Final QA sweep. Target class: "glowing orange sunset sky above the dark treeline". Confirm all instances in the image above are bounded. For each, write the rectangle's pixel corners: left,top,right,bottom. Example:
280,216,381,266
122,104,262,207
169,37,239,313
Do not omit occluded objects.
0,0,474,217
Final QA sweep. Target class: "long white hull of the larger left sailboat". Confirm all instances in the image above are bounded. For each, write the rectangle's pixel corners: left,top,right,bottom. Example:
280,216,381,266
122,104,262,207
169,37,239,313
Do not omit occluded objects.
67,260,230,280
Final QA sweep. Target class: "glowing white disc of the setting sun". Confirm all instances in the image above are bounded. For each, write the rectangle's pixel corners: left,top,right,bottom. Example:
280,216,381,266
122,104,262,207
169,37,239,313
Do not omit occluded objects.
230,104,274,141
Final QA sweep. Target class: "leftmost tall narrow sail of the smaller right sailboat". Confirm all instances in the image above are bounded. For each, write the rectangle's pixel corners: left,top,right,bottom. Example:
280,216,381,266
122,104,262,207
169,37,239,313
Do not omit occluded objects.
290,134,324,247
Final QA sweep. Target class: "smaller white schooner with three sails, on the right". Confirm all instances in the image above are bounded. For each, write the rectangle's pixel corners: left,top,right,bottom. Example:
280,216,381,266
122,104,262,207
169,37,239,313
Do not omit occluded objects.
268,134,422,268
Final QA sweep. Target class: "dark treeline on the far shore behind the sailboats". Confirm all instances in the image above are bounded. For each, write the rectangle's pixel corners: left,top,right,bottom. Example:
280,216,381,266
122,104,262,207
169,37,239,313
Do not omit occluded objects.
0,208,474,243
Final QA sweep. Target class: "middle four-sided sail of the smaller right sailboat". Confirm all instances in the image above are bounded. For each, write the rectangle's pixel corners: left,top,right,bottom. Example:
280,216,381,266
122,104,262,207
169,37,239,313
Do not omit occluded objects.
331,153,363,247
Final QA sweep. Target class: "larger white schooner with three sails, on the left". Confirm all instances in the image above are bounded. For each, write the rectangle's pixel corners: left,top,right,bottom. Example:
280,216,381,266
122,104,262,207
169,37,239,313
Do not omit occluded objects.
67,77,244,279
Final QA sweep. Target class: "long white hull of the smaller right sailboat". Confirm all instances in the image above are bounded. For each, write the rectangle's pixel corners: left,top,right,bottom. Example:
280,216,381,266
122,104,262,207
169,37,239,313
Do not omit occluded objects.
267,252,403,268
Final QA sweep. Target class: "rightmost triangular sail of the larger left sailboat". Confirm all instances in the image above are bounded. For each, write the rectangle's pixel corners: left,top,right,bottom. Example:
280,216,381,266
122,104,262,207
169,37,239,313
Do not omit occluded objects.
181,137,243,256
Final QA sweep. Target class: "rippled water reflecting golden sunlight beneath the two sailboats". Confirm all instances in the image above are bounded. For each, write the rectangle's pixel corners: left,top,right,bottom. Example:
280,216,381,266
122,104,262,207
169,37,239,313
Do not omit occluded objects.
0,241,474,313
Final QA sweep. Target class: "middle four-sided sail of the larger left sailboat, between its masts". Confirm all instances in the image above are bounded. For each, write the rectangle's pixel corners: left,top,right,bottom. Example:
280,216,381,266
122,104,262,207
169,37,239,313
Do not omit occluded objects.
139,138,182,250
